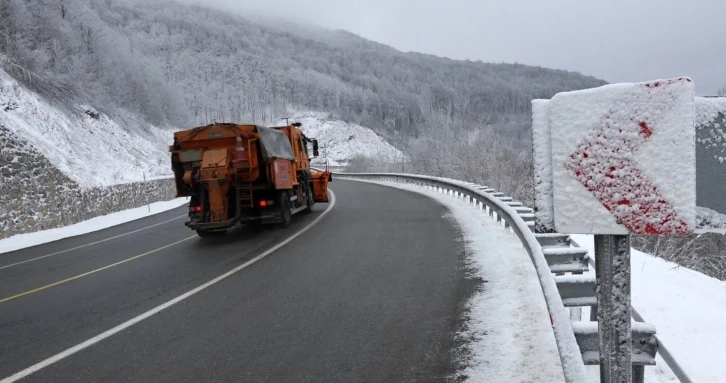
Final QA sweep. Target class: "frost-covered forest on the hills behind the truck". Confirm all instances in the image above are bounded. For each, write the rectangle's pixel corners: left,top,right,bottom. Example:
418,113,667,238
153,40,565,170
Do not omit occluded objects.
0,0,604,204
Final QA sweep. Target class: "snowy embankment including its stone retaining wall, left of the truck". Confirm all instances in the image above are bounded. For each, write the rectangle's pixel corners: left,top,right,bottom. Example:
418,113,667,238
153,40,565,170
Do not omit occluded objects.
0,70,182,238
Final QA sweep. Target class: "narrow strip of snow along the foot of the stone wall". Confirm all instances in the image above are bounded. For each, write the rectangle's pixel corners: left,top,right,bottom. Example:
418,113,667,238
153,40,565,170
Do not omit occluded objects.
0,198,188,255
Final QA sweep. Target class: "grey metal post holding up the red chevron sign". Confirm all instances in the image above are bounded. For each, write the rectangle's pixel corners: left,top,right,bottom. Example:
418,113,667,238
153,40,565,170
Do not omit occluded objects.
595,235,633,383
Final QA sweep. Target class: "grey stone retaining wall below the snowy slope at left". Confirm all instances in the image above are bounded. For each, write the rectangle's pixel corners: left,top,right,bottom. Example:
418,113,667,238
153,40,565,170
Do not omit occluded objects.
0,125,175,239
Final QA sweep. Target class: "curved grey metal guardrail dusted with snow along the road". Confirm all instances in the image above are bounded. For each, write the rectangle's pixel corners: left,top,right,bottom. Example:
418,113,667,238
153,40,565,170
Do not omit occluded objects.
334,173,691,383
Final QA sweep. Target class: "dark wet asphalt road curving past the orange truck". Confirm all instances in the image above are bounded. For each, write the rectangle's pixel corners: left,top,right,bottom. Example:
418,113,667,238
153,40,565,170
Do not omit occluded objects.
0,180,475,383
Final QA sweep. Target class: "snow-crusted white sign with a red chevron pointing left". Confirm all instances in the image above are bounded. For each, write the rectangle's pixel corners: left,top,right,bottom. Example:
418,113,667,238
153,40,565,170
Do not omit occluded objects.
532,77,696,235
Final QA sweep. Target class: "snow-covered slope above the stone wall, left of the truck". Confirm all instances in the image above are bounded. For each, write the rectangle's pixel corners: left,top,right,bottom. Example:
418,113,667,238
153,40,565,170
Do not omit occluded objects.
0,70,172,188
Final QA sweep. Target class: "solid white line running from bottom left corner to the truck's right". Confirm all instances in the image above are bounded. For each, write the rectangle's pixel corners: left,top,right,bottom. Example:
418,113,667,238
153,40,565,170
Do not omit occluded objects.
0,189,335,383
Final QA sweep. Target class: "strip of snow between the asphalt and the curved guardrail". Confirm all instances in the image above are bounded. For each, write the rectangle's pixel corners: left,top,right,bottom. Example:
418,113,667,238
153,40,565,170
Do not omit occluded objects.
356,180,564,383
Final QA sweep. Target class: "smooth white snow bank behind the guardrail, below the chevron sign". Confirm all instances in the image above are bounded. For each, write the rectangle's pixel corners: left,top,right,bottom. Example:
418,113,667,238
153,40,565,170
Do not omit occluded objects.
572,235,726,383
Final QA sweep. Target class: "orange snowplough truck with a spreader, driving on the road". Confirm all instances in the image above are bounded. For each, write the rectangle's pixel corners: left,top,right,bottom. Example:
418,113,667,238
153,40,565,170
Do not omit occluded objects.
169,123,332,237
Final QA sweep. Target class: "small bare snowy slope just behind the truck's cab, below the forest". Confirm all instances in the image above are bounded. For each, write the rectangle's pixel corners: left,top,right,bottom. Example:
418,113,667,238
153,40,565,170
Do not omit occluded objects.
276,112,401,166
